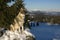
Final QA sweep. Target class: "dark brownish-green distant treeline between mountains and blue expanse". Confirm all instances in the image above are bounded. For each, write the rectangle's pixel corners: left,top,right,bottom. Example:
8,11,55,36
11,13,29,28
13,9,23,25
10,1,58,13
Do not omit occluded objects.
30,14,60,24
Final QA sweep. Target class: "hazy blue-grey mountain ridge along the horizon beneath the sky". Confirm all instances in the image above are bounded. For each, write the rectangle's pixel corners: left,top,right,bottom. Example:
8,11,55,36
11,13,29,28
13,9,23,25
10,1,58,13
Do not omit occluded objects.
29,11,60,16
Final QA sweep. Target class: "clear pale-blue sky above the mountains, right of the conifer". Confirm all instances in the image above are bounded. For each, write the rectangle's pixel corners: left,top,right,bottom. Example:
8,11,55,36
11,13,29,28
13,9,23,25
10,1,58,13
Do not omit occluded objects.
24,0,60,11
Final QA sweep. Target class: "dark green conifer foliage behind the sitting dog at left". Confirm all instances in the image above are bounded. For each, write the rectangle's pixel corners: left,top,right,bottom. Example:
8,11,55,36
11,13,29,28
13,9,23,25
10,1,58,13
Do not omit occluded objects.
0,0,25,28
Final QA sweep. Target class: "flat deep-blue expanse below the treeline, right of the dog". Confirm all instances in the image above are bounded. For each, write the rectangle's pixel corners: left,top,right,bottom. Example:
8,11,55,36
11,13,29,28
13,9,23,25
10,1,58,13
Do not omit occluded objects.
31,23,60,40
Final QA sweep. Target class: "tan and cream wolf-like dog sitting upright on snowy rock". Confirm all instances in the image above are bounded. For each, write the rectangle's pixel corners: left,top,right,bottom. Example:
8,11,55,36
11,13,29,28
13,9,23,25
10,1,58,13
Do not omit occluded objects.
10,8,25,32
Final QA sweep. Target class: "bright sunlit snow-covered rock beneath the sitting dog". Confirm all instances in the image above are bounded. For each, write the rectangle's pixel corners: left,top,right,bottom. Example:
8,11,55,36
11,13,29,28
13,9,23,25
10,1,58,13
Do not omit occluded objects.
0,30,33,40
